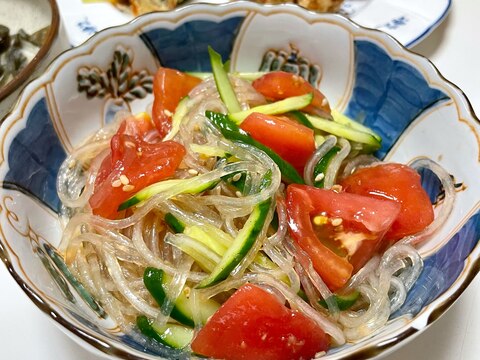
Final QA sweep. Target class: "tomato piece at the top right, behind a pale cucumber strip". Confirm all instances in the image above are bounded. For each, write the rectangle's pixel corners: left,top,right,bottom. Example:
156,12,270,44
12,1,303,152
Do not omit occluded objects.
252,71,331,118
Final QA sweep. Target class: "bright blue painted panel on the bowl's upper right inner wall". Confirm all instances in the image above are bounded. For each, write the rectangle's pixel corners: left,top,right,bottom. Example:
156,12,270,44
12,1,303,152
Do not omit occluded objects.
346,40,449,158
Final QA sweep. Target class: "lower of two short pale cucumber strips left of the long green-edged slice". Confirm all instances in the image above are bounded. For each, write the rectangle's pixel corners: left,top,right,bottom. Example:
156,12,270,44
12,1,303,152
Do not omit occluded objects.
167,234,221,272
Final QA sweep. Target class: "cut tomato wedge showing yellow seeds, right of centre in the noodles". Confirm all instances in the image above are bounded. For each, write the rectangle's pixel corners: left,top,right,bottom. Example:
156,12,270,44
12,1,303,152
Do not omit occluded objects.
286,184,400,291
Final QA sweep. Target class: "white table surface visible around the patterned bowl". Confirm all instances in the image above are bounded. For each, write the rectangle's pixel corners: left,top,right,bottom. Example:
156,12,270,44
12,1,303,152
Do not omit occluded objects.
0,0,480,360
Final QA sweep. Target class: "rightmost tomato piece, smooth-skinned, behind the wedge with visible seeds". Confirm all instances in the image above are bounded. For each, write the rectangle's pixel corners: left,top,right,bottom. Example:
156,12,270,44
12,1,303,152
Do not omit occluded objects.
341,163,435,242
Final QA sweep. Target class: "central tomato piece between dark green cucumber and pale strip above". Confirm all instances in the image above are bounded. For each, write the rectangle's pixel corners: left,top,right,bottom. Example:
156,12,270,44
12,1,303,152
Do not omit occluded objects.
240,113,315,174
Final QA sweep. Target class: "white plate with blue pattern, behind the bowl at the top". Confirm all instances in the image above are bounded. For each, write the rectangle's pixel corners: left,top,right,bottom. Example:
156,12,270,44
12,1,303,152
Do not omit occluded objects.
57,0,452,47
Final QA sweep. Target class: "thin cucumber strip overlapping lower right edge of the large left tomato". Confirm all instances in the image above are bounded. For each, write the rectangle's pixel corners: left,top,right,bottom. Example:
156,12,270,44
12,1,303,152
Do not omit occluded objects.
118,176,219,211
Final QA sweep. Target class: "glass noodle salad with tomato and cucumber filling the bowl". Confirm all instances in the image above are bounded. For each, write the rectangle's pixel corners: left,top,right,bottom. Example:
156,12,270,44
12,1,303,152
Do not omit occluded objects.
57,49,455,359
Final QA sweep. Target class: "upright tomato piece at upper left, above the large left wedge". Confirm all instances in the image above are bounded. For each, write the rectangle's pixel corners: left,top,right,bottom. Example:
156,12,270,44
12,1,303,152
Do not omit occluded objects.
152,67,202,138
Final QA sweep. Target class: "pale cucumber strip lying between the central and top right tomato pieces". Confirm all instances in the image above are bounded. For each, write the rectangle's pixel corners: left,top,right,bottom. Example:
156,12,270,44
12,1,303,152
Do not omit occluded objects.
228,93,313,124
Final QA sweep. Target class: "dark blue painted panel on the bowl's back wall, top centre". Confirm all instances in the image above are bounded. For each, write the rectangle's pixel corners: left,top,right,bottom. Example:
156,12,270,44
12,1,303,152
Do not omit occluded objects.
140,17,243,71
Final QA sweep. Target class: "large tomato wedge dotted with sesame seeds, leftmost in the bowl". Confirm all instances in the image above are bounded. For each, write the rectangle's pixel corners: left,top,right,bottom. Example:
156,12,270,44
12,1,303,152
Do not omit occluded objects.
89,116,185,219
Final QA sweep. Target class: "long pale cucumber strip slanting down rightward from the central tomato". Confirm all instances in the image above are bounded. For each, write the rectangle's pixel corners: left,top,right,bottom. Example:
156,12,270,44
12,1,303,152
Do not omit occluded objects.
305,114,381,150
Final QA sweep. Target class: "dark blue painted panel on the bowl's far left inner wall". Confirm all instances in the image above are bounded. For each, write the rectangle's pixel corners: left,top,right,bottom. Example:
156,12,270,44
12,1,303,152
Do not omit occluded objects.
2,98,66,212
